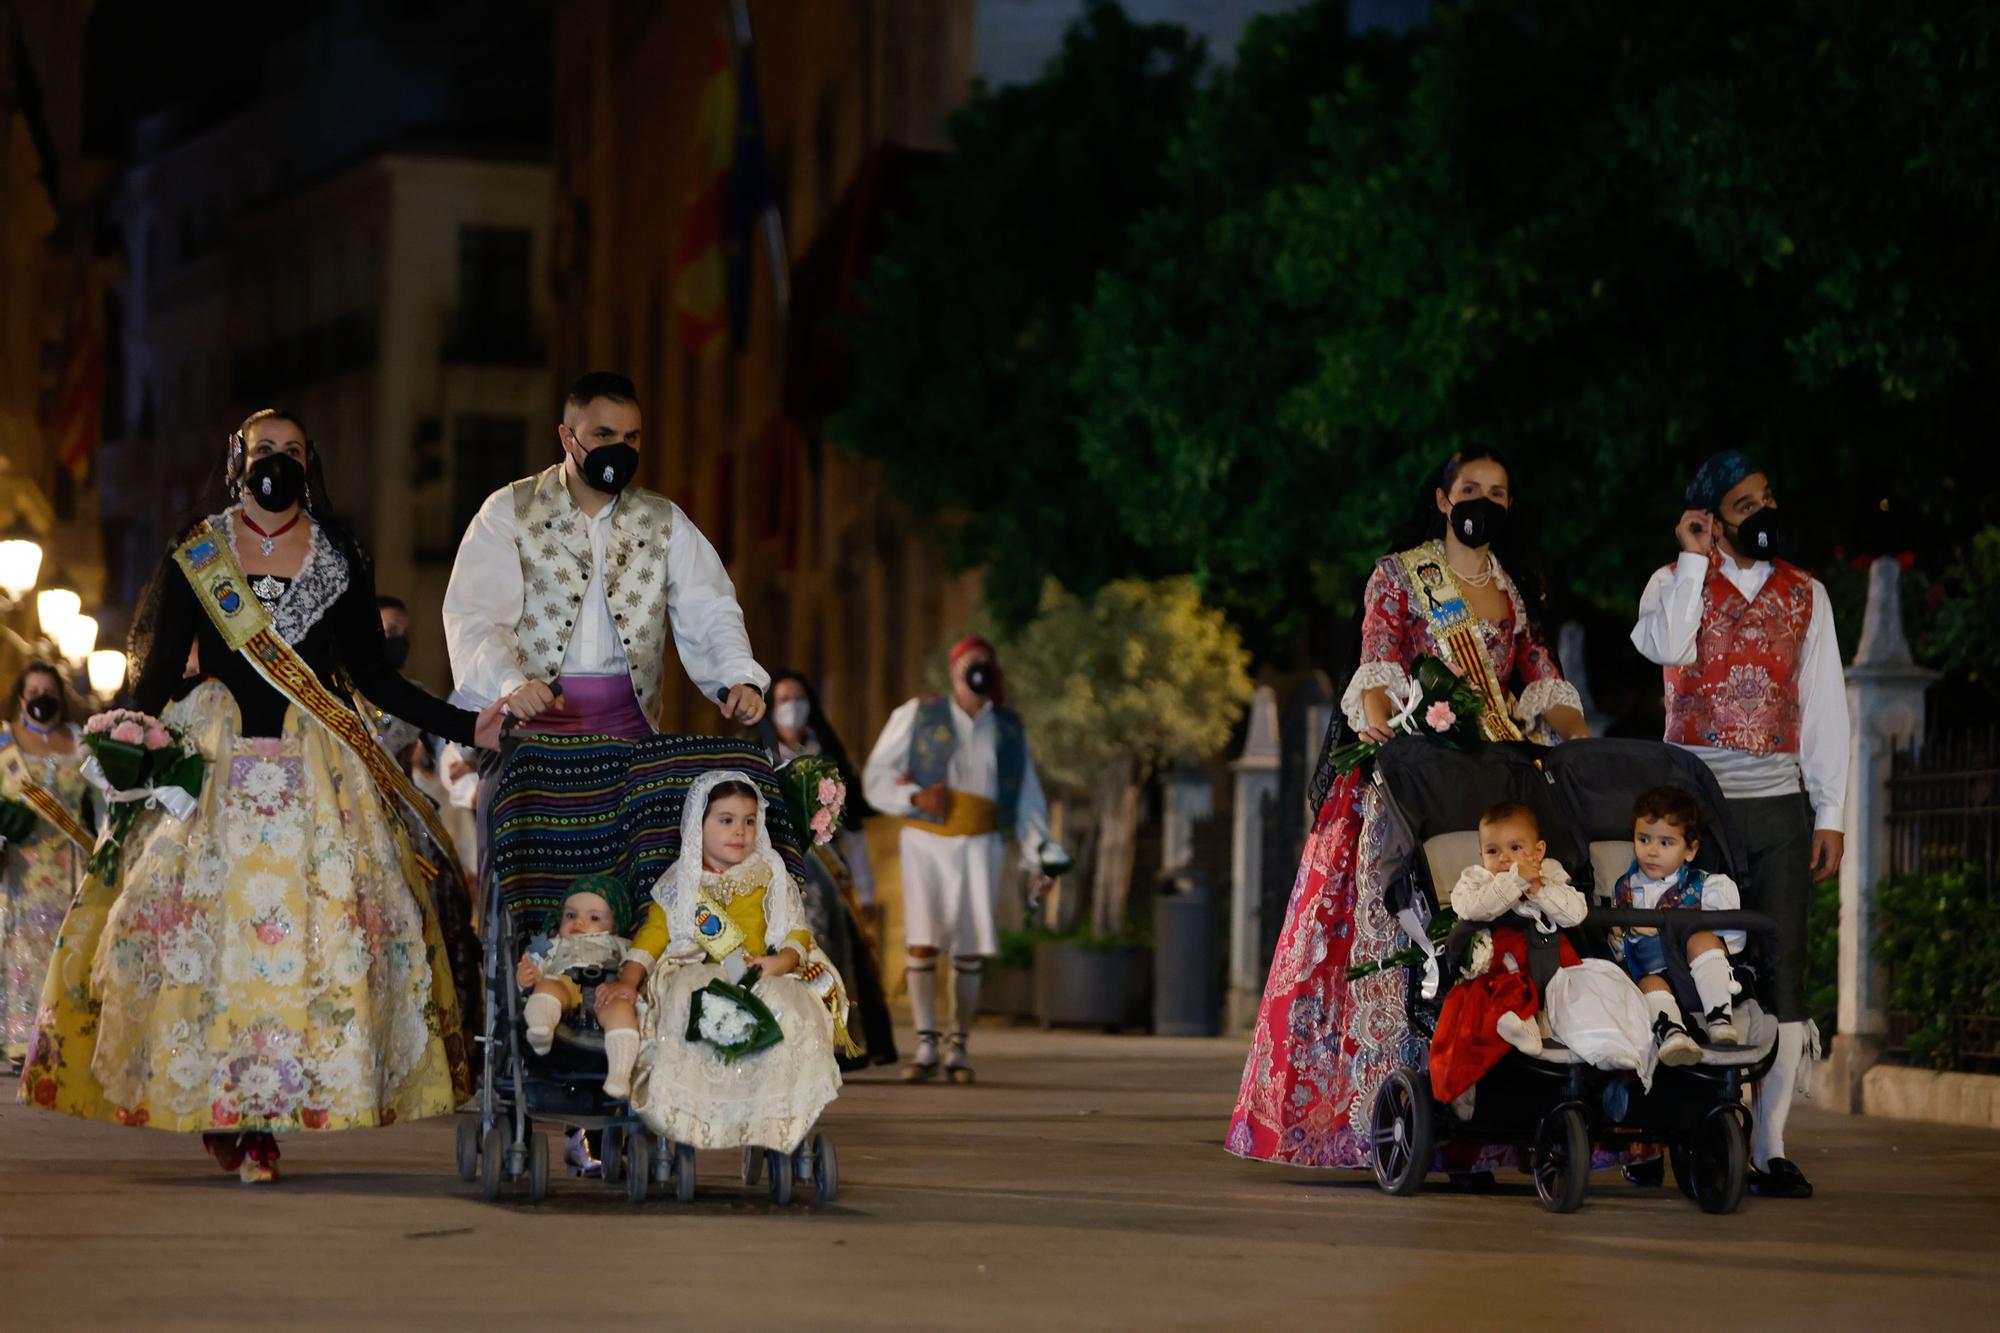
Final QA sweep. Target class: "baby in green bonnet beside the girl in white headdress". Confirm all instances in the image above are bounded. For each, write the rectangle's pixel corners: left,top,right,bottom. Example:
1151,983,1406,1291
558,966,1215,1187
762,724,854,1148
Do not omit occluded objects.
514,875,638,1097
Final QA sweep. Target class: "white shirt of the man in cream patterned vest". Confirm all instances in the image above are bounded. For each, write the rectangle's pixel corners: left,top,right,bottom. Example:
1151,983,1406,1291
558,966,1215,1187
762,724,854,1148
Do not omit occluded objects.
444,486,770,707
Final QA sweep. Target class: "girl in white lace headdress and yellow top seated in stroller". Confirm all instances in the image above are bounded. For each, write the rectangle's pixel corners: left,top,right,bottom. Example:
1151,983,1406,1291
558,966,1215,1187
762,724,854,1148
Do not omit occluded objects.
616,771,848,1153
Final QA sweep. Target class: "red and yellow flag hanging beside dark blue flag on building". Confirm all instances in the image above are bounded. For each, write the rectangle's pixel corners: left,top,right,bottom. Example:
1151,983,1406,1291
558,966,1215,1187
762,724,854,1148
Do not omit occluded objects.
674,10,784,352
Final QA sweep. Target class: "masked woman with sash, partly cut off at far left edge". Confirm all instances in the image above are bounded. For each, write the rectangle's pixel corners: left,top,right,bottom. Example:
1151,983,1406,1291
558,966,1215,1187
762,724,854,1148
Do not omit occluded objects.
0,662,96,1063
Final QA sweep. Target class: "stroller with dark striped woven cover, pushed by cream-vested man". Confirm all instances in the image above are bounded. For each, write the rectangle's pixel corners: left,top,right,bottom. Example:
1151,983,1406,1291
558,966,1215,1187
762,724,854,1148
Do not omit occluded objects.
458,735,840,1205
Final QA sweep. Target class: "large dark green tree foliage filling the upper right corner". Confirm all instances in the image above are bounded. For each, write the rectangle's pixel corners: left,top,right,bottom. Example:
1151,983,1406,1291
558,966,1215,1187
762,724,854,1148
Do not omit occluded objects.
1078,0,2000,648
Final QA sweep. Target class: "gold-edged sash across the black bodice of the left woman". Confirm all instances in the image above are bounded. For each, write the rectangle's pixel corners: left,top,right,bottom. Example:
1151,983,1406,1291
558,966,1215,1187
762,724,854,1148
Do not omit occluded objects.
174,522,458,881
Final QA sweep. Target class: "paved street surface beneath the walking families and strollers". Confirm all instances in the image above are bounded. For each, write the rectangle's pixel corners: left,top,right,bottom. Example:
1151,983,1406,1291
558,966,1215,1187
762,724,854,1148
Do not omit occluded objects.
0,1029,2000,1329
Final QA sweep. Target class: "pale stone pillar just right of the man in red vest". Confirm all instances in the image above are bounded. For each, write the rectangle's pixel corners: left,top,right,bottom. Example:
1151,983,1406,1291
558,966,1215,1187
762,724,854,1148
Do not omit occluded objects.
1820,556,1938,1113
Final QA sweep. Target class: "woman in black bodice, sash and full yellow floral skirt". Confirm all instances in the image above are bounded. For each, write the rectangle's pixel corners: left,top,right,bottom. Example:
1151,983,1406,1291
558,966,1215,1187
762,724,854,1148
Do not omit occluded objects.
22,410,498,1181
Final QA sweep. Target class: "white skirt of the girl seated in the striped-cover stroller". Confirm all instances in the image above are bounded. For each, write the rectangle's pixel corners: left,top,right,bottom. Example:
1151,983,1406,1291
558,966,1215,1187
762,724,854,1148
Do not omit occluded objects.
632,959,840,1153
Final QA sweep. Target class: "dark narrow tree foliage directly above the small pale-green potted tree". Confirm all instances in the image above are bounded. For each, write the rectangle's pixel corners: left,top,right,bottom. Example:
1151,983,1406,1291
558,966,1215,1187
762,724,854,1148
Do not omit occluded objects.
832,0,1204,624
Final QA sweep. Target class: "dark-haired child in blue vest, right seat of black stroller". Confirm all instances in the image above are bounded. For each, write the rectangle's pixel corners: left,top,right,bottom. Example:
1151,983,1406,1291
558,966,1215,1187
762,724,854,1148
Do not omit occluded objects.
1610,787,1744,1065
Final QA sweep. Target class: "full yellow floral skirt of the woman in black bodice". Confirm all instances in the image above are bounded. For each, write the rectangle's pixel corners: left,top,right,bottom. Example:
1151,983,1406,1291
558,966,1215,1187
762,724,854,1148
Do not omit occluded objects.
22,683,470,1131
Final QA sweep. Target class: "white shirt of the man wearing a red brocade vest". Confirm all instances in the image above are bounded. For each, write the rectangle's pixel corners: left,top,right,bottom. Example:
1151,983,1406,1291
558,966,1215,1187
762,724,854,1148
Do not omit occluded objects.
1632,552,1848,833
